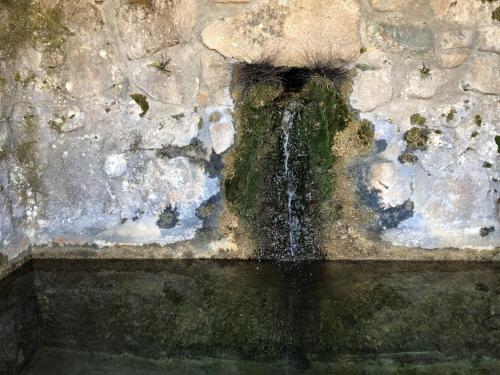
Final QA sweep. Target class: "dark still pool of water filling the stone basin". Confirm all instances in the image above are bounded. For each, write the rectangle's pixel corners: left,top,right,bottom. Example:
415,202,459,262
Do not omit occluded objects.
0,260,500,375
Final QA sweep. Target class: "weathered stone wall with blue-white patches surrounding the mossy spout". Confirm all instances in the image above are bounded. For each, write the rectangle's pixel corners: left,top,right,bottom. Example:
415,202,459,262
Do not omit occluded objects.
0,0,500,259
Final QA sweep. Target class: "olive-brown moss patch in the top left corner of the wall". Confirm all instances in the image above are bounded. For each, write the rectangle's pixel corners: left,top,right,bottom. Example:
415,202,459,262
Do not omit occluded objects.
0,0,68,57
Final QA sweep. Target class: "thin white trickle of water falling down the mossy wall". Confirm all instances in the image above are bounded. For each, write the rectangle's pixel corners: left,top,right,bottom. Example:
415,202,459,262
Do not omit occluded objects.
282,108,301,257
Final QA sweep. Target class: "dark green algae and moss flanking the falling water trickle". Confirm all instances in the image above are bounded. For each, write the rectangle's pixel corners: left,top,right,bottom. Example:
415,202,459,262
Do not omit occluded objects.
225,76,348,259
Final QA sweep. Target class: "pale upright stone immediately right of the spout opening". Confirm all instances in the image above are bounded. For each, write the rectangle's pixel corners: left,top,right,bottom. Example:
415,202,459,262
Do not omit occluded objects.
350,53,392,112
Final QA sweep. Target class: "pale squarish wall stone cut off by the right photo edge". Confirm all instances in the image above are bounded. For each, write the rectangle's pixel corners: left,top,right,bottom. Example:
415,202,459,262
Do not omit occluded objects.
464,52,500,95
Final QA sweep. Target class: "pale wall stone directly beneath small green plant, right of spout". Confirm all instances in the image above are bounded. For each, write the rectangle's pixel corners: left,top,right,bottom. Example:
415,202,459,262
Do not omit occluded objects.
404,69,446,99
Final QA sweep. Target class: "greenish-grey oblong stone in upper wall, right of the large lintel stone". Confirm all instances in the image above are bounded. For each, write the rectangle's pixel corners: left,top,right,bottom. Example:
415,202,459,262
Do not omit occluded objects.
368,21,434,53
